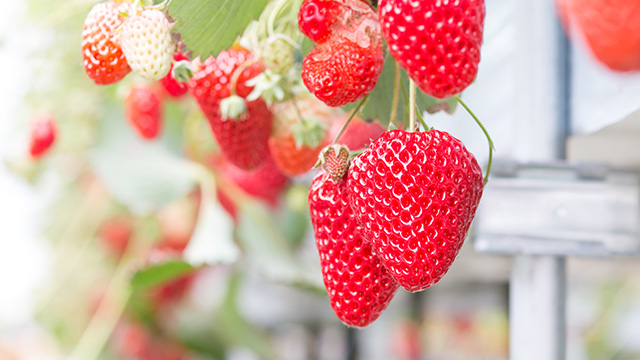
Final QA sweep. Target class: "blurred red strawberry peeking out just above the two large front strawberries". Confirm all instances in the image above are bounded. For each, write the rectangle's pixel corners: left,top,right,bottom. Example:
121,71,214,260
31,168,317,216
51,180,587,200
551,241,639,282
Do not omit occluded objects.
329,115,386,150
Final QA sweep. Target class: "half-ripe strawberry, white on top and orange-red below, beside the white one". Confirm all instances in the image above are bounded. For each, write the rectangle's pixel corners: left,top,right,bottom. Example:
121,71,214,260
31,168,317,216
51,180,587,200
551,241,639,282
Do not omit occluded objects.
82,1,131,85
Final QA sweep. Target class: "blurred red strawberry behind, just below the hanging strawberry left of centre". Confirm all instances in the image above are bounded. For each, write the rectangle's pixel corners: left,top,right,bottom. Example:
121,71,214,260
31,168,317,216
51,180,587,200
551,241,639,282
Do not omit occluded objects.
212,156,289,219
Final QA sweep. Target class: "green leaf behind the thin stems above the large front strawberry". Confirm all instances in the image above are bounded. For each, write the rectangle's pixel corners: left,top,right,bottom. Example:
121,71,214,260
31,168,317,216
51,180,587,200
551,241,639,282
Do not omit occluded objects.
343,56,457,126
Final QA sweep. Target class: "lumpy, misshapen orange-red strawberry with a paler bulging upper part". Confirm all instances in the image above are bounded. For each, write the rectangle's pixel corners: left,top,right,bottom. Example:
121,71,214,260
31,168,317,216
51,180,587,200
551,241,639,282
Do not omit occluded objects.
302,0,384,106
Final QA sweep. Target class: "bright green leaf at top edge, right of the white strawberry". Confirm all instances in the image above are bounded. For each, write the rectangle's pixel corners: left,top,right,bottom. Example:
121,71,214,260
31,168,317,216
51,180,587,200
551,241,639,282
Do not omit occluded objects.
168,0,268,59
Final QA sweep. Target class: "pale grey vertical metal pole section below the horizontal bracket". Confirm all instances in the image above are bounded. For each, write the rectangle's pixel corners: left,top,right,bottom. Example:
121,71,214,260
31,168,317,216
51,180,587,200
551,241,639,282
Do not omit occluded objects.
509,255,566,360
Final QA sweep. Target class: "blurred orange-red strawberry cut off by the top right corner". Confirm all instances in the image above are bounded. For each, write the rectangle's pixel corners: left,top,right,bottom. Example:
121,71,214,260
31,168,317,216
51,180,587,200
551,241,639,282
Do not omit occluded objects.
556,0,640,71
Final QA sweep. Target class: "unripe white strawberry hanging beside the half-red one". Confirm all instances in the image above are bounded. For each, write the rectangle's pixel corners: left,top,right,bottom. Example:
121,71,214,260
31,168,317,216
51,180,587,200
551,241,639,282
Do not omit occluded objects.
120,9,176,81
